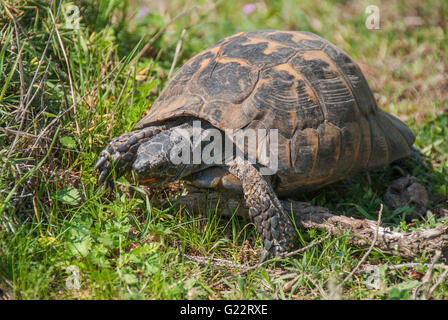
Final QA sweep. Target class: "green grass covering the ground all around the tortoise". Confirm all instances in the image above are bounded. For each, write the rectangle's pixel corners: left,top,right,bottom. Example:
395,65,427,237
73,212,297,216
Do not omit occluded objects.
0,0,448,299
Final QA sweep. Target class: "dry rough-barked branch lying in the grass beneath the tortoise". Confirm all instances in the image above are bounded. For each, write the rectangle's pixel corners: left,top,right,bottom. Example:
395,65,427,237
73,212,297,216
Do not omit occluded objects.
173,188,448,259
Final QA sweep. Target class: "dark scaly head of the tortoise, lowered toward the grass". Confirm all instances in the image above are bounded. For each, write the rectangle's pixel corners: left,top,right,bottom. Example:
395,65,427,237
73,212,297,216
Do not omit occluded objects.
133,120,222,185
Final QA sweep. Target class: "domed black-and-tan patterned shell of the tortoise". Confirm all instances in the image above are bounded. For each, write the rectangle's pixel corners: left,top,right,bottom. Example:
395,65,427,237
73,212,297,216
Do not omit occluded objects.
136,30,414,194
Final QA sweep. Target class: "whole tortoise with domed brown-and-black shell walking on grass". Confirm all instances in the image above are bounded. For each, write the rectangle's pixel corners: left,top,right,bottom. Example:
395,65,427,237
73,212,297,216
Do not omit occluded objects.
95,30,415,260
